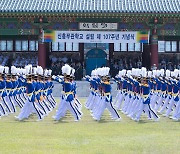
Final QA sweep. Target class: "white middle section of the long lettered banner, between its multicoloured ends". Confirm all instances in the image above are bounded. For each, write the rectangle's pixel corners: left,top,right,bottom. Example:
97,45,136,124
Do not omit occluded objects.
55,31,148,43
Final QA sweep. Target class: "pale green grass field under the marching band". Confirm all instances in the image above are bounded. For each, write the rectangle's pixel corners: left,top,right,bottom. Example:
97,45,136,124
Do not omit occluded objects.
0,99,180,154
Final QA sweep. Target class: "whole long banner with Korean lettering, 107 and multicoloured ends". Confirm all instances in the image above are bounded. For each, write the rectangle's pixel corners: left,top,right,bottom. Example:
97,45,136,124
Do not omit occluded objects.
43,31,149,43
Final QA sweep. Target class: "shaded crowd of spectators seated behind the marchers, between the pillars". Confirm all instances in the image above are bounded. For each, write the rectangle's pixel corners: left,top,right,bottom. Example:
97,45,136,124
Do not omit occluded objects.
0,53,180,80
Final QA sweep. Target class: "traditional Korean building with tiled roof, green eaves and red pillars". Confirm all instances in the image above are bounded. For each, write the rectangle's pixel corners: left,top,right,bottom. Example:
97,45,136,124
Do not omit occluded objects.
0,0,180,72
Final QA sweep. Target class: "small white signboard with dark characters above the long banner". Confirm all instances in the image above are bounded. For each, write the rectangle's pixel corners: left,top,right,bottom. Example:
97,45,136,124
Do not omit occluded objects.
79,23,118,30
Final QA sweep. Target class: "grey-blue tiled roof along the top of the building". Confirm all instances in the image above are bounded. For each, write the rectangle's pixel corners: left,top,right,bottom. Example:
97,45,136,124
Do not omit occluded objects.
0,0,180,13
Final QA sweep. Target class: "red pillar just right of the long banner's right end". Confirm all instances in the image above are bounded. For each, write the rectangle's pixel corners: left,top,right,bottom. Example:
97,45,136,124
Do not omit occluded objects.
151,29,158,68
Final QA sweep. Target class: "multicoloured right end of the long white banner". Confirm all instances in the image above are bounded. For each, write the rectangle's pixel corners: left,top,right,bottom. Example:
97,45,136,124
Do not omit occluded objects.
136,31,149,43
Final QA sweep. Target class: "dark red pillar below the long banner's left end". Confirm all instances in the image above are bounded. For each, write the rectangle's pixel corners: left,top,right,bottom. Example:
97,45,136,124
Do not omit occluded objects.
38,42,47,68
